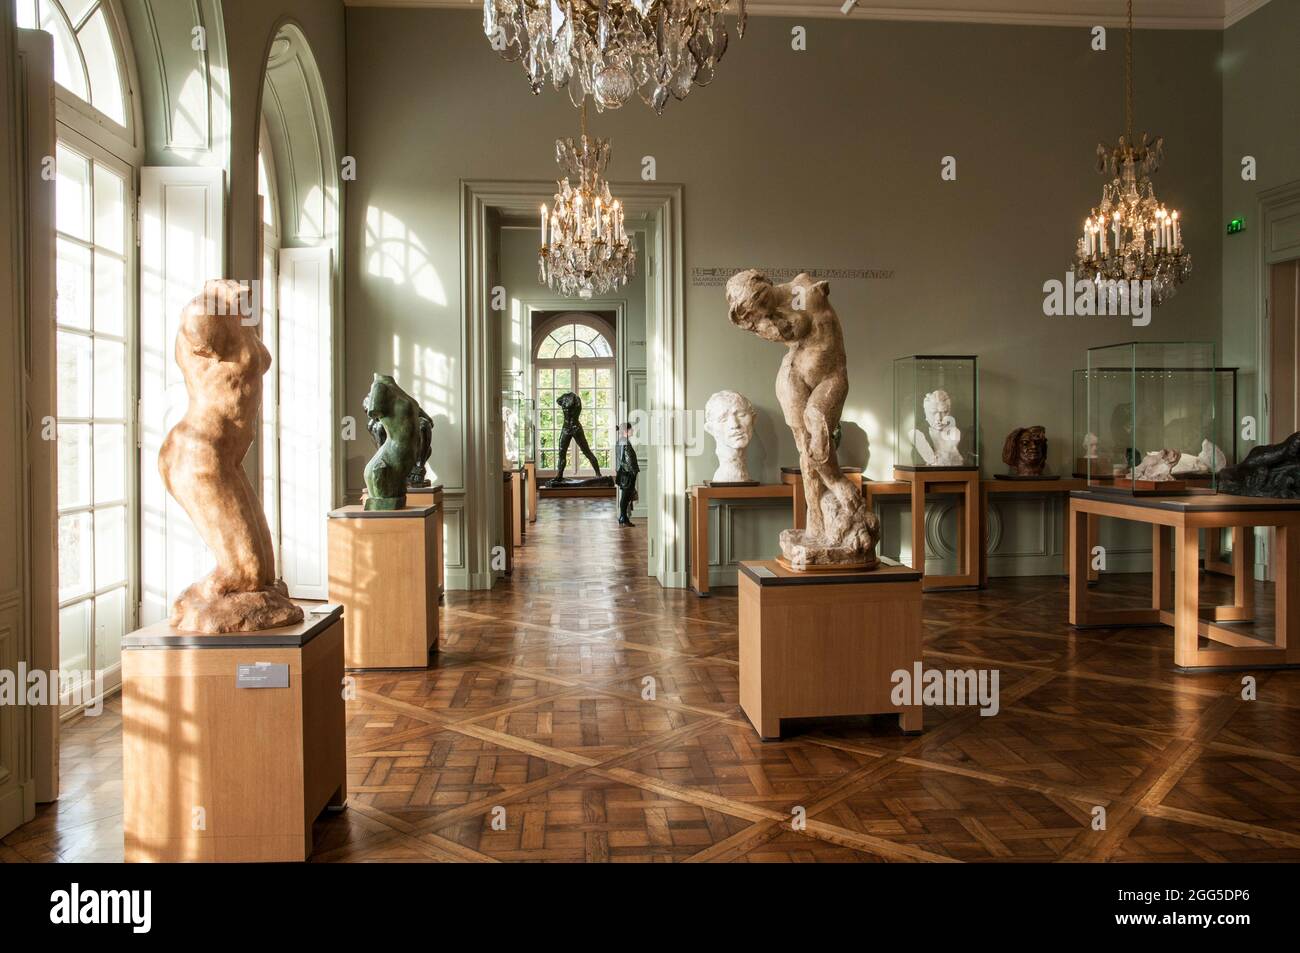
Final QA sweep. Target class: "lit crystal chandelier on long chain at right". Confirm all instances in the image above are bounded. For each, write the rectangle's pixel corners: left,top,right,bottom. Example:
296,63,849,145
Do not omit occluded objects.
1074,0,1192,306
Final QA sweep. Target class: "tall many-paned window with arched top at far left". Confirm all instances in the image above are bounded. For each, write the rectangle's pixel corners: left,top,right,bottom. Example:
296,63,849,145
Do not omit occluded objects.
17,0,138,688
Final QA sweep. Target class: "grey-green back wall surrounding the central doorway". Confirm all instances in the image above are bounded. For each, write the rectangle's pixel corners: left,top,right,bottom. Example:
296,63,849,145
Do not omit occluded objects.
347,8,1222,499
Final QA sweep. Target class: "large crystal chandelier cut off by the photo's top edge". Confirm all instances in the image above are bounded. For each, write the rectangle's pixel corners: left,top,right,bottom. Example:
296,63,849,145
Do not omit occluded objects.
484,0,746,114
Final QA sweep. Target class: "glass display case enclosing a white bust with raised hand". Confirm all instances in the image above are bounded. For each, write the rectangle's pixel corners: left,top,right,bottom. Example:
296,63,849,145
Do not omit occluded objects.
893,354,979,469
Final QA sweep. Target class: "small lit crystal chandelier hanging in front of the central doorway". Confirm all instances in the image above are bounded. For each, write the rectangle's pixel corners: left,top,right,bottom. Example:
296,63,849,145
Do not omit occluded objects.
537,104,637,298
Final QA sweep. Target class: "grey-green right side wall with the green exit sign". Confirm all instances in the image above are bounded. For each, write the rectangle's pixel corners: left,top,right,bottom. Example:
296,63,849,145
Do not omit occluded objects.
1219,0,1300,442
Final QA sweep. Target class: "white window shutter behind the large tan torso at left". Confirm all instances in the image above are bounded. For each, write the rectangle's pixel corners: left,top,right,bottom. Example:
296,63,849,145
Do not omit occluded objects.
137,166,225,625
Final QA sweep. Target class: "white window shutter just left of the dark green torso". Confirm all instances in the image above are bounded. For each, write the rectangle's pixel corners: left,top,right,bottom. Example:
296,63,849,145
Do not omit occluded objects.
276,247,334,599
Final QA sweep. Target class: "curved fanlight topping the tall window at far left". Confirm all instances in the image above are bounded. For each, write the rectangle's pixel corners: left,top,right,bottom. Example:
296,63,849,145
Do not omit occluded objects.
18,0,130,127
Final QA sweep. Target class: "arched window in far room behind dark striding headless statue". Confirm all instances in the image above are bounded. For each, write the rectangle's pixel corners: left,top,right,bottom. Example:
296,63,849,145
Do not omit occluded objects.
533,317,616,476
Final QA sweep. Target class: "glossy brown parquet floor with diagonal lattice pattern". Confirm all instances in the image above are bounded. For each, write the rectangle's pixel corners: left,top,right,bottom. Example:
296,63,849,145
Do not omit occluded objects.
0,499,1300,862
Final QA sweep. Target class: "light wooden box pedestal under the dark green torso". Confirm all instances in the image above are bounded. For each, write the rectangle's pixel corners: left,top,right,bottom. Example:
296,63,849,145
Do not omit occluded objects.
329,498,439,668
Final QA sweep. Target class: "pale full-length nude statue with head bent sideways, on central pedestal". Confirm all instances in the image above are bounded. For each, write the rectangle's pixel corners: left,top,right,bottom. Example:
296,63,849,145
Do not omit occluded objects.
727,270,880,569
